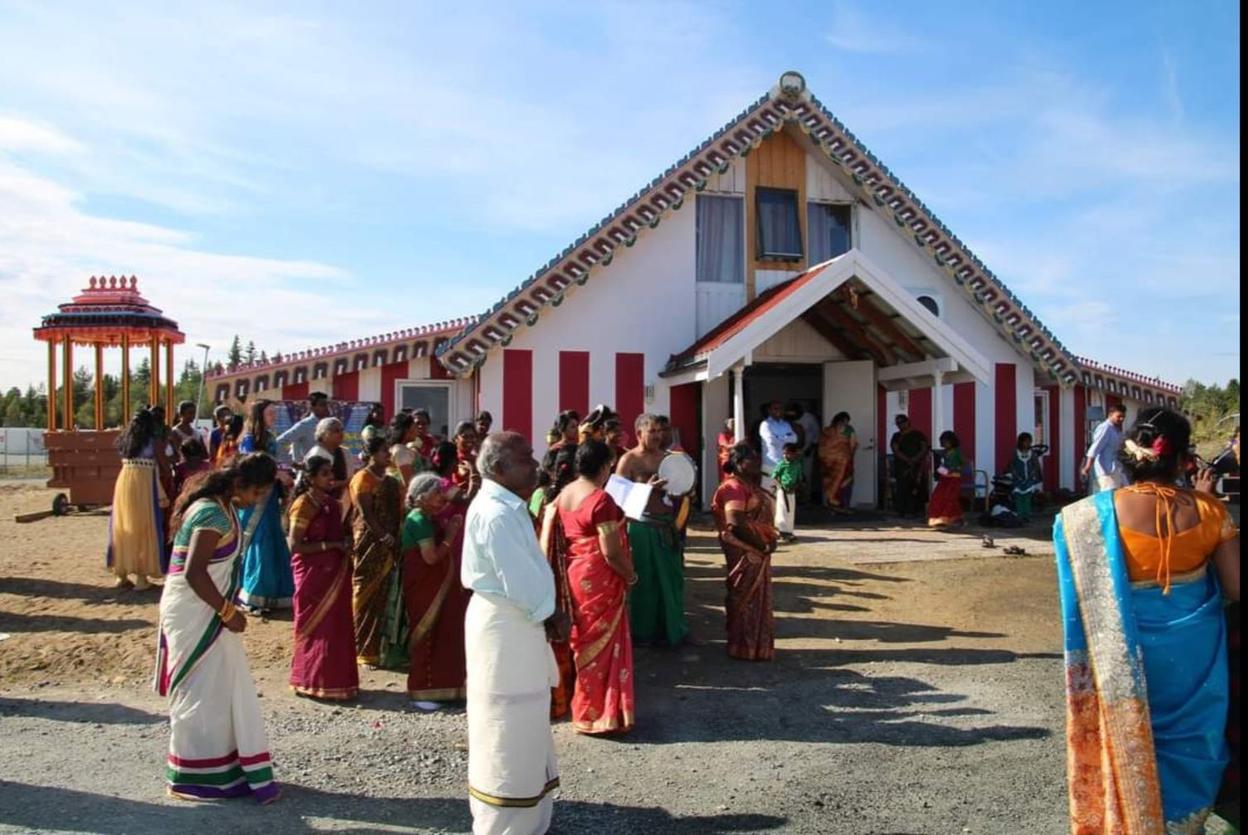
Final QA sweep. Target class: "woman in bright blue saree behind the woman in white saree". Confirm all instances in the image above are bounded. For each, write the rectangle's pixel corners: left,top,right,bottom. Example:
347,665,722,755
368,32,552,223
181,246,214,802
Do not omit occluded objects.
238,399,295,614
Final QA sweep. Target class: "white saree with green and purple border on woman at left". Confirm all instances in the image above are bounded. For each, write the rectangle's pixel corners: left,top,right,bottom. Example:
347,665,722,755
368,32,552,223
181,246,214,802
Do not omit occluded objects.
155,499,278,803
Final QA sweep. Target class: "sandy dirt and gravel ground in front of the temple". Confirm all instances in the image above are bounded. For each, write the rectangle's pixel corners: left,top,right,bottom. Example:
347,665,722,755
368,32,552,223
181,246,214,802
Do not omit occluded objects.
0,482,1163,835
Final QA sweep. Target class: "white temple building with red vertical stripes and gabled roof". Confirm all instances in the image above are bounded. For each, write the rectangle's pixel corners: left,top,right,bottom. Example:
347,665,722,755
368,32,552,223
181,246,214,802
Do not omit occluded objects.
208,72,1179,504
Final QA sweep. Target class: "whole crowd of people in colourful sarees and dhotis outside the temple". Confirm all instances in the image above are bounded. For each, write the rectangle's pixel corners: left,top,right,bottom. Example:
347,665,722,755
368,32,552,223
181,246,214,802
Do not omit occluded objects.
99,394,1238,833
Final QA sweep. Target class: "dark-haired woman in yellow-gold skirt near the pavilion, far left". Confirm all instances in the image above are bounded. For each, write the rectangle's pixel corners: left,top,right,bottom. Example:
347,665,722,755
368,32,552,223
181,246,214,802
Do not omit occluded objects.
105,409,168,592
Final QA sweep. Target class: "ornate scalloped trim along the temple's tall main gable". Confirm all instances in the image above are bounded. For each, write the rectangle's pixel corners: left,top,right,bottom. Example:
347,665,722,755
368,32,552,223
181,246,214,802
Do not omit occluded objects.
438,72,1080,386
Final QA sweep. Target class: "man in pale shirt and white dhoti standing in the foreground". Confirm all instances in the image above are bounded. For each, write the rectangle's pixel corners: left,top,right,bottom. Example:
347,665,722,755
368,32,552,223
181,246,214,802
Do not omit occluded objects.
461,432,569,835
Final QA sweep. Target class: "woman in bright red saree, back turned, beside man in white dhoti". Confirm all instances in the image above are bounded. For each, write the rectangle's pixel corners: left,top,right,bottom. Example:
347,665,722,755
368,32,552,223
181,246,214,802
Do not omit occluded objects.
540,441,636,734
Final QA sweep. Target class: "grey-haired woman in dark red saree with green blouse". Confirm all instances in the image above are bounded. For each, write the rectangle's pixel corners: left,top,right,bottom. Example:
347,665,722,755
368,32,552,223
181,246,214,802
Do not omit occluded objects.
402,473,472,710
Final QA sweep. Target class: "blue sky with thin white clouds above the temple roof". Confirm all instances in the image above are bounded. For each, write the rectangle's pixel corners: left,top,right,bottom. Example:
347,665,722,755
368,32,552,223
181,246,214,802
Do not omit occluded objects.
0,0,1239,388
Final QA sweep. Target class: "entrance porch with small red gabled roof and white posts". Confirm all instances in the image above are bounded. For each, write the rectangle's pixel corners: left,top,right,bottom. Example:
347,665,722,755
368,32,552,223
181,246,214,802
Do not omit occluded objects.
661,250,992,507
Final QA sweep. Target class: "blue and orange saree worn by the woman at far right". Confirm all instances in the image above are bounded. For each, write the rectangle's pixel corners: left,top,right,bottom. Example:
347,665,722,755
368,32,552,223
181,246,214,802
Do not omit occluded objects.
1053,492,1228,835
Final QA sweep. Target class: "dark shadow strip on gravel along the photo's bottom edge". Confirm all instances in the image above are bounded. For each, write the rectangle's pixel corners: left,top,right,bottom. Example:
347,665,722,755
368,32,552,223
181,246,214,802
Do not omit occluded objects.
0,780,786,835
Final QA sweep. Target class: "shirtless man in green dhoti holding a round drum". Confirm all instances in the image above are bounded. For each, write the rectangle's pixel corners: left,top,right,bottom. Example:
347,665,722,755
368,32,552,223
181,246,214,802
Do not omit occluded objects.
615,413,689,647
